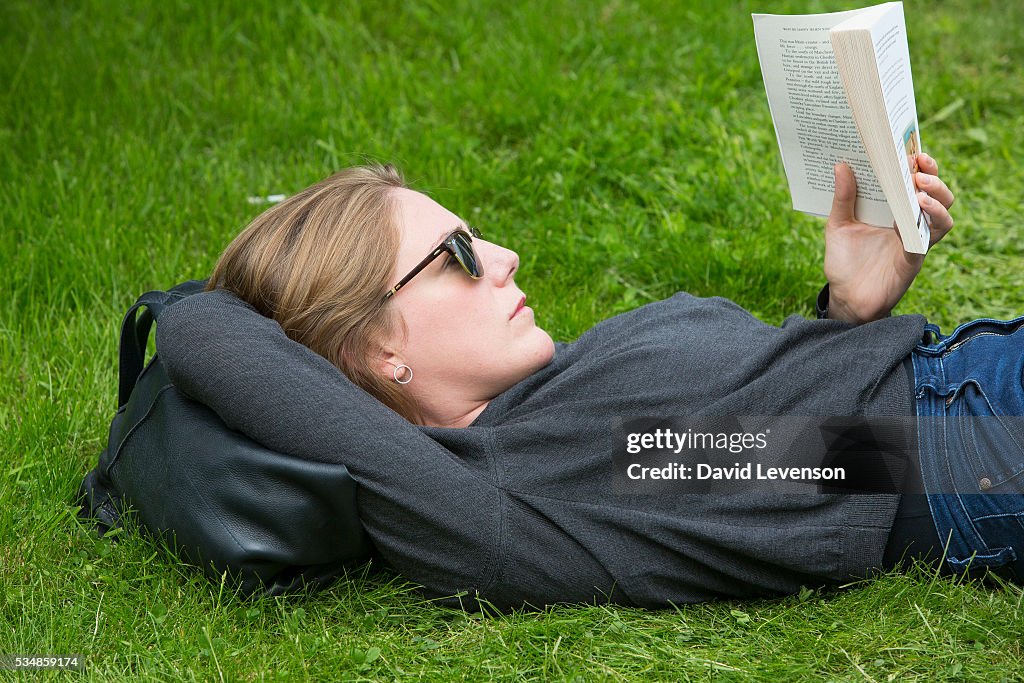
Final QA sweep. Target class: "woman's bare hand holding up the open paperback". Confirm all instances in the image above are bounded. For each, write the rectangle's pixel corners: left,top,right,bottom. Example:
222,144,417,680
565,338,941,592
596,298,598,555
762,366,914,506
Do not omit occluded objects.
824,154,953,325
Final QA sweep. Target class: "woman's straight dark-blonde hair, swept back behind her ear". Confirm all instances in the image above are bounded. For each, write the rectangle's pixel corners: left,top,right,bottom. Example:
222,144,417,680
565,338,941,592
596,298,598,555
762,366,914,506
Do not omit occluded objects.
207,164,422,424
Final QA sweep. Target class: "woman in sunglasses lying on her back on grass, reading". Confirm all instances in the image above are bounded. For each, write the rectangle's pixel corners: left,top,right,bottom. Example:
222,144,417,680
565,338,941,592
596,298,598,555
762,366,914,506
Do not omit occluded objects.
158,155,1024,607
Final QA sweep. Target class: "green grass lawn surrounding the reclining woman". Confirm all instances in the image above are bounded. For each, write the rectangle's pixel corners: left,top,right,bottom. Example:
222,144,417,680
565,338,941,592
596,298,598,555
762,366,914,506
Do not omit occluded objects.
0,0,1024,681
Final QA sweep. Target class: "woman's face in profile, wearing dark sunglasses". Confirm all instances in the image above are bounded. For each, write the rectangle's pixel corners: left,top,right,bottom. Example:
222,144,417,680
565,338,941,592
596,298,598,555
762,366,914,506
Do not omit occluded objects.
384,189,554,426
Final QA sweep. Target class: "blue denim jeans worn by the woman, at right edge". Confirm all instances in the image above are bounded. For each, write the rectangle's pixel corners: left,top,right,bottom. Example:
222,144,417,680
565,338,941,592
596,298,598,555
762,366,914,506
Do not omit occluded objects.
910,316,1024,583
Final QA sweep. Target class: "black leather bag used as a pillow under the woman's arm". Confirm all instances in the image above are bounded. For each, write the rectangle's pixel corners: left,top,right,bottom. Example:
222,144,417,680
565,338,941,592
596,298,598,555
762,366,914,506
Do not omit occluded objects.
79,281,371,595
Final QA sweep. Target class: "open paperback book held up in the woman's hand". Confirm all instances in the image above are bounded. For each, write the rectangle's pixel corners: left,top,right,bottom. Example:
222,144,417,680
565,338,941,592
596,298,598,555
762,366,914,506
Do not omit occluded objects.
754,2,929,254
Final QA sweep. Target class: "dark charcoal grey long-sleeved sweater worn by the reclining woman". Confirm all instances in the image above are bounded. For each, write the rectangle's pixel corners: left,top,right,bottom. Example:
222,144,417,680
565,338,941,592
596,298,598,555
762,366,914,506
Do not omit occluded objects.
157,291,925,608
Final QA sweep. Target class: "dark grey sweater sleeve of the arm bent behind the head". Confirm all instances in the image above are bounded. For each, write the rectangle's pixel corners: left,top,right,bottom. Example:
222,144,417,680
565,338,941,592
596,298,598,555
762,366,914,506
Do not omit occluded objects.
157,290,503,599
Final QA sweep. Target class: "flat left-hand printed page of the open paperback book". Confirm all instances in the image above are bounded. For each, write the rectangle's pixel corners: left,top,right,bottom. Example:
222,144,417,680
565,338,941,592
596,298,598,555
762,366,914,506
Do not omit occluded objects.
754,10,893,226
